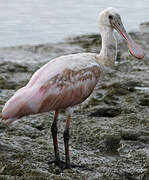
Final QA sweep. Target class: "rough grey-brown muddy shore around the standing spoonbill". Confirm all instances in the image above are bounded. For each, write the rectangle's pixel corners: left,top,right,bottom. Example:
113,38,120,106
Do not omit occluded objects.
0,23,149,180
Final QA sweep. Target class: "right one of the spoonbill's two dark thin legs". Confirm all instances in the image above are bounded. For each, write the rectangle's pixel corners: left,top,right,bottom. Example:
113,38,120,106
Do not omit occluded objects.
63,115,71,168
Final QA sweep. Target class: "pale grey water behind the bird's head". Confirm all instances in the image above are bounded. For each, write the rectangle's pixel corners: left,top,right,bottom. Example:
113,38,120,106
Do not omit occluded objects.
0,0,149,46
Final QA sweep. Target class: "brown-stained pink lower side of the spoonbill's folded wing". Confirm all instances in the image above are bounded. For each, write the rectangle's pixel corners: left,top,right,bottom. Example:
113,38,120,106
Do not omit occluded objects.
38,66,100,112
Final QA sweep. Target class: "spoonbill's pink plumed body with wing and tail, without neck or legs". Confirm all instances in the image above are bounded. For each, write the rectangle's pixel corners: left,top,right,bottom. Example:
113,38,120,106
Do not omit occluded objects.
2,54,100,119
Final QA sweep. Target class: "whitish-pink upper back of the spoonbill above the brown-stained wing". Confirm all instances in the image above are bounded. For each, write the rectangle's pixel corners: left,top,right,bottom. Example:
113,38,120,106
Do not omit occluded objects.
26,53,97,87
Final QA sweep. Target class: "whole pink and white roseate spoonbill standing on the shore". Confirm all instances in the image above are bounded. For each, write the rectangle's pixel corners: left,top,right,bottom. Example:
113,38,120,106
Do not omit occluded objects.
1,8,144,168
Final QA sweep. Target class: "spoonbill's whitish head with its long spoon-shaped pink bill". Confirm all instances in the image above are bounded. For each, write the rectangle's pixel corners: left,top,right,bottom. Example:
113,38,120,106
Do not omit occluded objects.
99,7,144,59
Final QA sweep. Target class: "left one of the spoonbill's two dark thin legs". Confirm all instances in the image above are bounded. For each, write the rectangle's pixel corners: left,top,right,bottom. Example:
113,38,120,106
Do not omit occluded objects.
51,110,60,165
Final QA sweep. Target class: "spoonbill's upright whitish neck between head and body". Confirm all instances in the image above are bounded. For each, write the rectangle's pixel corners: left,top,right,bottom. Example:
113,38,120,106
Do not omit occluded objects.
97,27,117,66
